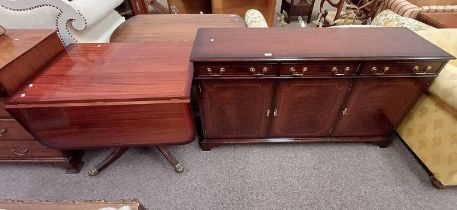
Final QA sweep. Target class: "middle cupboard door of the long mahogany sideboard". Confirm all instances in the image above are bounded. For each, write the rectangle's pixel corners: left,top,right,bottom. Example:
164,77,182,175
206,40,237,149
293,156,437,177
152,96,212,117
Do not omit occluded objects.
270,79,351,138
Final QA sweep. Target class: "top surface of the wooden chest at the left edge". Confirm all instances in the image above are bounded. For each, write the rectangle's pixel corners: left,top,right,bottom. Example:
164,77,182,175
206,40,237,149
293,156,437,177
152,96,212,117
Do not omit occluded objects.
0,29,55,69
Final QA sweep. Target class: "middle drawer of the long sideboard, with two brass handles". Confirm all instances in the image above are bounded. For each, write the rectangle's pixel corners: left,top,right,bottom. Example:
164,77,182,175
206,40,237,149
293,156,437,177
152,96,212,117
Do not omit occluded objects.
280,63,359,77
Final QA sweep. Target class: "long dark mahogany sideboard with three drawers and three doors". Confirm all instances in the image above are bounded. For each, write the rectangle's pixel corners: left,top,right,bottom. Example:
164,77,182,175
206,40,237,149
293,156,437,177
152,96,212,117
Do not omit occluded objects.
191,28,453,150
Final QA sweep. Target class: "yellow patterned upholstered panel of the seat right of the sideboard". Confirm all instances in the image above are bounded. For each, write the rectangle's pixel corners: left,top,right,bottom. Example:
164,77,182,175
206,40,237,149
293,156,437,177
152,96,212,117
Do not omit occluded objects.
397,95,457,185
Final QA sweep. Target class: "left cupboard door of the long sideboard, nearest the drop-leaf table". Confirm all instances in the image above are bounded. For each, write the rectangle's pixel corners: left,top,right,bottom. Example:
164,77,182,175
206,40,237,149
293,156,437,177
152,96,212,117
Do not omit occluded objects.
200,80,274,139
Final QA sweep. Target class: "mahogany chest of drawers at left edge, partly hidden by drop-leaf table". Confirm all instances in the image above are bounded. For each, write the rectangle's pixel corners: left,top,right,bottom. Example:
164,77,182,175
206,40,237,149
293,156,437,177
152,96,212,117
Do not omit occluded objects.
0,29,83,173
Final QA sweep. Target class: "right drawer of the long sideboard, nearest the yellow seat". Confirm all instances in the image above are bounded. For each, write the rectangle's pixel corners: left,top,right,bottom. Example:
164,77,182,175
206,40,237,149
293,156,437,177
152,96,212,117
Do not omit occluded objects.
361,61,443,76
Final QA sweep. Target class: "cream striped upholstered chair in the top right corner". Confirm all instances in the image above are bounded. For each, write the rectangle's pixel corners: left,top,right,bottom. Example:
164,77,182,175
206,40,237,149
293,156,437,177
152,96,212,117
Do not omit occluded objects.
380,0,457,18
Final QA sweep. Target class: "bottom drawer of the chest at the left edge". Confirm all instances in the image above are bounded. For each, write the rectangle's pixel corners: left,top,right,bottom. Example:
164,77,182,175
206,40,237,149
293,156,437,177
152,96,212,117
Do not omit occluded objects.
0,141,62,159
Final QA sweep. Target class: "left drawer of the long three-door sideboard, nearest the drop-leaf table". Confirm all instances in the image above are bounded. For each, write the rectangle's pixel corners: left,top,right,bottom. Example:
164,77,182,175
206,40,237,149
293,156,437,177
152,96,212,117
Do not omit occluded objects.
198,63,278,77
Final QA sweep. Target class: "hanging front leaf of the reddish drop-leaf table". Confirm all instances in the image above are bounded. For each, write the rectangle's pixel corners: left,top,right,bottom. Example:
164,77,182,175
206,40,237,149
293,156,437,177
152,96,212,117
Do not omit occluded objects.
6,101,195,149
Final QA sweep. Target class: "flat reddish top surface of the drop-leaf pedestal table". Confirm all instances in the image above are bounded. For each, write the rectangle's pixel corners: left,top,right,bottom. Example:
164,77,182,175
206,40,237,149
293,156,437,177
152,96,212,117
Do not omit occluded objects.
8,42,193,105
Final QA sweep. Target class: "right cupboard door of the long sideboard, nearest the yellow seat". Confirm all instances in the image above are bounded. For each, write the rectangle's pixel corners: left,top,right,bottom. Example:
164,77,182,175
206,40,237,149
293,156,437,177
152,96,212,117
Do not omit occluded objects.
332,78,432,137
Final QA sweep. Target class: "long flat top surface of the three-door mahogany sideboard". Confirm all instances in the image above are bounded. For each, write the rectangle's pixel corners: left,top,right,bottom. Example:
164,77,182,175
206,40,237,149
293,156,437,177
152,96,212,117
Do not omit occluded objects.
191,27,453,62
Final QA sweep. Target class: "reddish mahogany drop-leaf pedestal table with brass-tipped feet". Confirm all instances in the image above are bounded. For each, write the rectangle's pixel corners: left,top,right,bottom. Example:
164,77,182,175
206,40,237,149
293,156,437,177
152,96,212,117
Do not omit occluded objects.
6,42,195,175
